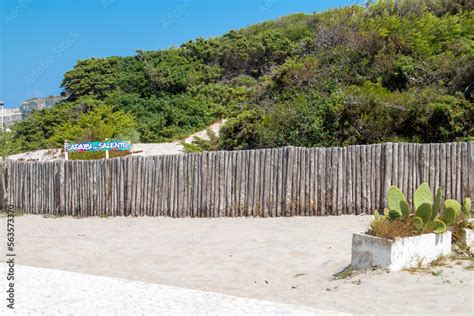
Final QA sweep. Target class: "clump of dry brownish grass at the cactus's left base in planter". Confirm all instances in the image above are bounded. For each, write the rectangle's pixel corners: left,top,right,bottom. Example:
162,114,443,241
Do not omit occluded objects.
367,217,416,239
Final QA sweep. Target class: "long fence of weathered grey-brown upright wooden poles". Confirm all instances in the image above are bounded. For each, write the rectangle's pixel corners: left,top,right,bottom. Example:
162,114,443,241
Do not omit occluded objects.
0,142,474,217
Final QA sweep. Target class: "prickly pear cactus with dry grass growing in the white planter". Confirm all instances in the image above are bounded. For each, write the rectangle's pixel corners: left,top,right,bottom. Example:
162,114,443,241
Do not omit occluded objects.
367,183,470,239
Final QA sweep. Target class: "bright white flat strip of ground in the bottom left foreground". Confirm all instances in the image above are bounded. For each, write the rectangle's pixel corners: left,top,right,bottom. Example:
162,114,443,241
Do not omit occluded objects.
0,266,351,316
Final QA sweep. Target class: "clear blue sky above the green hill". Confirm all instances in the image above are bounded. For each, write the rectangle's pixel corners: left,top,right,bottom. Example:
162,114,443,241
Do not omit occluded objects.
0,0,361,107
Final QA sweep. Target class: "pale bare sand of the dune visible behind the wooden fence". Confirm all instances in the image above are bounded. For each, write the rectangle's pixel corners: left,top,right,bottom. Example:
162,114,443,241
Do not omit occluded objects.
8,119,226,160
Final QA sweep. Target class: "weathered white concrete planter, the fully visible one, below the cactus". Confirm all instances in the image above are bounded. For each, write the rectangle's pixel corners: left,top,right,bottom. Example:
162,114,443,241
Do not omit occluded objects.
351,231,451,271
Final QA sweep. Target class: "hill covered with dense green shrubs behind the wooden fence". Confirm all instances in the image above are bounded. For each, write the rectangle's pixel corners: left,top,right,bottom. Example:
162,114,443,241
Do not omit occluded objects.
4,0,474,151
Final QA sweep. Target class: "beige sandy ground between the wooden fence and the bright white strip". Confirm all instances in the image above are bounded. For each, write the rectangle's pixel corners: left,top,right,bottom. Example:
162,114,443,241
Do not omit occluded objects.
0,215,474,315
